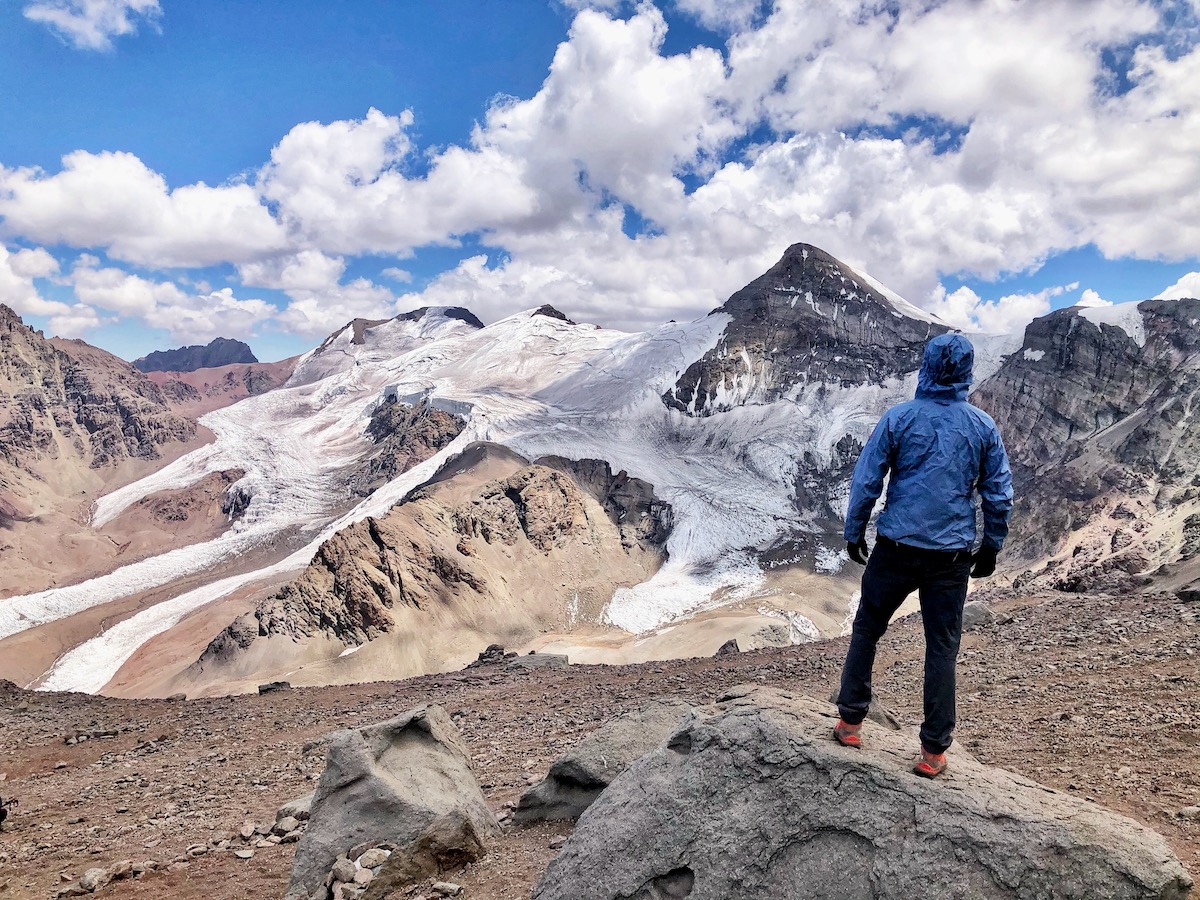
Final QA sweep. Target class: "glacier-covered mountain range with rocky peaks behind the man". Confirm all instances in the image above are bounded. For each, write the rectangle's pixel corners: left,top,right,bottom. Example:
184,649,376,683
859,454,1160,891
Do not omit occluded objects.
0,244,1200,695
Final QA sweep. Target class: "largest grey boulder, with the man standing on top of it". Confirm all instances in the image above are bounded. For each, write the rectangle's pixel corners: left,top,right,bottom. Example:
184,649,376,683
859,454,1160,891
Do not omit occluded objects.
533,689,1192,900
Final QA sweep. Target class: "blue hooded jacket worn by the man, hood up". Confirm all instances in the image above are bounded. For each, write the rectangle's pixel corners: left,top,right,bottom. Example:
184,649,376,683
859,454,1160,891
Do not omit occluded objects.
845,334,1013,550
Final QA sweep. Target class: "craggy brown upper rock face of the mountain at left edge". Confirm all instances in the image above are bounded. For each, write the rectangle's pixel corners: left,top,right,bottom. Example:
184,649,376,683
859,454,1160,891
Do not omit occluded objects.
0,306,196,473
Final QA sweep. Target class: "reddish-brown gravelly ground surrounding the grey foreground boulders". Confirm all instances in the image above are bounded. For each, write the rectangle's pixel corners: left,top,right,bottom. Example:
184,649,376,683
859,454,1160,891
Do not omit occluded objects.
0,594,1200,900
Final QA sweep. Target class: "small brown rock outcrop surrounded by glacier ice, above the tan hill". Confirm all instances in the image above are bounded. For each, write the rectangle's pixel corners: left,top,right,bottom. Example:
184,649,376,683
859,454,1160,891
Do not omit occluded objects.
350,401,466,496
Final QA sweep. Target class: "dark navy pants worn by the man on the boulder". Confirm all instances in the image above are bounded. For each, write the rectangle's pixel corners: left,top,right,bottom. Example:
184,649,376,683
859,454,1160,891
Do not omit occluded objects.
838,535,971,754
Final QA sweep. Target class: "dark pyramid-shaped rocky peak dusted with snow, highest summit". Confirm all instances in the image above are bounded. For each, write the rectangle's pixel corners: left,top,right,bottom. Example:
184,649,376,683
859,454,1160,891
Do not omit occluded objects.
662,244,949,415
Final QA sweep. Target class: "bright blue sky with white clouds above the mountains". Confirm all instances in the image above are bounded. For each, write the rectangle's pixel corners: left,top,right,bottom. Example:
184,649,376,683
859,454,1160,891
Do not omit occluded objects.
0,0,1200,359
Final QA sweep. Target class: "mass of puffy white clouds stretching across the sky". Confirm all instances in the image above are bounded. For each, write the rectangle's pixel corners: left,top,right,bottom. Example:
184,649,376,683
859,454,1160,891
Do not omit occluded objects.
0,0,1200,340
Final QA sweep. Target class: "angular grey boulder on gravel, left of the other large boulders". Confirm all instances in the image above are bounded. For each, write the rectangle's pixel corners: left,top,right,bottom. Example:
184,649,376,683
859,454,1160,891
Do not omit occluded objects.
287,706,500,900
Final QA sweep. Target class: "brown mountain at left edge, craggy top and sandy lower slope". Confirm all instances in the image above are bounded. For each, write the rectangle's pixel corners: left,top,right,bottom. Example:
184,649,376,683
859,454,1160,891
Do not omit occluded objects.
0,305,196,602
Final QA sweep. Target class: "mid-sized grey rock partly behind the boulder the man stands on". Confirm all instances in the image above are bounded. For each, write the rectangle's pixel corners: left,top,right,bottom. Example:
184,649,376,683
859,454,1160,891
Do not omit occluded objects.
512,701,691,824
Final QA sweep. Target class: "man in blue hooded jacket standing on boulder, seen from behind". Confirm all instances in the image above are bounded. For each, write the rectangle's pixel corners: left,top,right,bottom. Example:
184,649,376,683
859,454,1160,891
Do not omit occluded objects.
834,335,1013,778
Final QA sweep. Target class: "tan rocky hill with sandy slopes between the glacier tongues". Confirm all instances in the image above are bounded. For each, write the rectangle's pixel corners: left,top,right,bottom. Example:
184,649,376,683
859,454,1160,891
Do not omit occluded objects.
196,451,670,691
